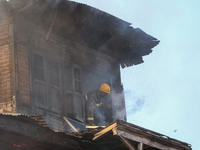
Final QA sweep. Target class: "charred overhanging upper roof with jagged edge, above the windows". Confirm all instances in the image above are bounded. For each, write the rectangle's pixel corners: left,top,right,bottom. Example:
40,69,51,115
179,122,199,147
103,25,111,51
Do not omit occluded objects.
1,0,159,68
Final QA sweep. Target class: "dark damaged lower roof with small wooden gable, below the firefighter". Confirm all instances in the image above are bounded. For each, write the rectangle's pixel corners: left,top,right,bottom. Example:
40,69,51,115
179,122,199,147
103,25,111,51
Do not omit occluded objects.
0,114,191,150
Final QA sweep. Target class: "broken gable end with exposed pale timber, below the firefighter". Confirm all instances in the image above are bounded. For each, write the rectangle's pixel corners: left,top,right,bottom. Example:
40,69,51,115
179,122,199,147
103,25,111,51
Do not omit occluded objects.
93,120,191,150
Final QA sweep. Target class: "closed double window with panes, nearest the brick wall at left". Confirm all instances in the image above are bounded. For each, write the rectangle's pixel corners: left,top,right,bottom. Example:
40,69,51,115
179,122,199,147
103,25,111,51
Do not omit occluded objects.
33,54,62,113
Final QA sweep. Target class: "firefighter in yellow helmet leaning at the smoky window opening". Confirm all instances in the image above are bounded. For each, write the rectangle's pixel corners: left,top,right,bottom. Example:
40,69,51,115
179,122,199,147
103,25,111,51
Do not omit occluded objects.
85,83,110,126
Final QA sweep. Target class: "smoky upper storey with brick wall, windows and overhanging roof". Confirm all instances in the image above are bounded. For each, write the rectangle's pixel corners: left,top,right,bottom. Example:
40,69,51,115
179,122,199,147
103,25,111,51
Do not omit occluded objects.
0,0,159,130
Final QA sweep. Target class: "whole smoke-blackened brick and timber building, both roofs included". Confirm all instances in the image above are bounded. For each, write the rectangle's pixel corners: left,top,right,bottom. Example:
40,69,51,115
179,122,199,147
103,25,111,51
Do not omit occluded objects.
0,0,191,150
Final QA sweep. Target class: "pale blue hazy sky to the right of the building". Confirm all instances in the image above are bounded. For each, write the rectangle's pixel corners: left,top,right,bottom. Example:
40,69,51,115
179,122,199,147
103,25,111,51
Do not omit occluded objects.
76,0,200,150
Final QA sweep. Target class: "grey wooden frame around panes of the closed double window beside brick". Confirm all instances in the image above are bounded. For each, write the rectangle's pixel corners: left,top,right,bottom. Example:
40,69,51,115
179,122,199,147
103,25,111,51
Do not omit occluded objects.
31,50,63,114
